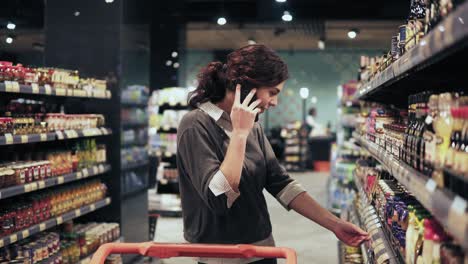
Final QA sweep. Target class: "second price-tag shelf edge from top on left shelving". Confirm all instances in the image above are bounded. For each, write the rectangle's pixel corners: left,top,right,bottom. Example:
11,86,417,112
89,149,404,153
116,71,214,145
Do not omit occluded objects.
0,128,112,146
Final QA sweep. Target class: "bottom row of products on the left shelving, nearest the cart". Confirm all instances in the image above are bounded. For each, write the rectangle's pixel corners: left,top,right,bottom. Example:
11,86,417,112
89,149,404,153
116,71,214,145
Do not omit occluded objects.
0,221,120,264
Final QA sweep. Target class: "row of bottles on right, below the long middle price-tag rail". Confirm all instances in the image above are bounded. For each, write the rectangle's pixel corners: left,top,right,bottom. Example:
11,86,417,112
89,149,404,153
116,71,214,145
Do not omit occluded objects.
355,160,466,264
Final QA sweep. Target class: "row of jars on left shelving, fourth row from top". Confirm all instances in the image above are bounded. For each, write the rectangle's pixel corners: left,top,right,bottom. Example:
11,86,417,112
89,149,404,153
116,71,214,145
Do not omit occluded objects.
0,180,107,237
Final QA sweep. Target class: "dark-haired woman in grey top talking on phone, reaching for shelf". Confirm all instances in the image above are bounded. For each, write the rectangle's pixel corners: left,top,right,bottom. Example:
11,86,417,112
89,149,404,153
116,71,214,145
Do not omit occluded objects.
177,45,368,264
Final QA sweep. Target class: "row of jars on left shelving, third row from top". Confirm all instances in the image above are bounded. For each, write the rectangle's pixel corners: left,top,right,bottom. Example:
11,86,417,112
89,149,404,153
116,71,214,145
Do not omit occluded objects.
0,139,107,188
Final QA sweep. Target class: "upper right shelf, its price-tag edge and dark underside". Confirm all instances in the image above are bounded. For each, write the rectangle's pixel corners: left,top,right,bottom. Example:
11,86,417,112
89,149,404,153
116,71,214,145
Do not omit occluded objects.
355,1,468,105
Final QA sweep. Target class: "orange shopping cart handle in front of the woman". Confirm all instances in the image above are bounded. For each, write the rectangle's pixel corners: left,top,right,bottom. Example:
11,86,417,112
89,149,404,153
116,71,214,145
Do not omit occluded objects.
91,242,297,264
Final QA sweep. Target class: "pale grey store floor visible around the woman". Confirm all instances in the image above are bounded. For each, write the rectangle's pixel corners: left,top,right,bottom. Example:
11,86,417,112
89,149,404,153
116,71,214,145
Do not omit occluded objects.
156,172,338,264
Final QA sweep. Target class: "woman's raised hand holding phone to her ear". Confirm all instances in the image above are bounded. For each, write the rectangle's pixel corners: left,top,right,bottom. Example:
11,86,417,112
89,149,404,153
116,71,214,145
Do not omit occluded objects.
231,84,261,137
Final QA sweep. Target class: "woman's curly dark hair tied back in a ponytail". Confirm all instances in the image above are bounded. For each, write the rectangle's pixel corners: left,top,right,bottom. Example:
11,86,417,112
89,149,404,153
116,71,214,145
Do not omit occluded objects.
188,44,289,108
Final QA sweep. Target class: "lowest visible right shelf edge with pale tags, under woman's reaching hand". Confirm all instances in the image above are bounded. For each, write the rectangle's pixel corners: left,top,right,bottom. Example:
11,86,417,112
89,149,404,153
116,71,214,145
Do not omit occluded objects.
354,175,404,264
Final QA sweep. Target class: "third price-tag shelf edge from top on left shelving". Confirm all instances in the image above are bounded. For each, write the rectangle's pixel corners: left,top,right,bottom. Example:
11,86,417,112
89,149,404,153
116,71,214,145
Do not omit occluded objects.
0,164,111,200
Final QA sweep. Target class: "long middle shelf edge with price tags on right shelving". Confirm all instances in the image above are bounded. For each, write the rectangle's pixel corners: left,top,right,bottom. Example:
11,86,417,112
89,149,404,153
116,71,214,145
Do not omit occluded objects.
353,133,468,250
